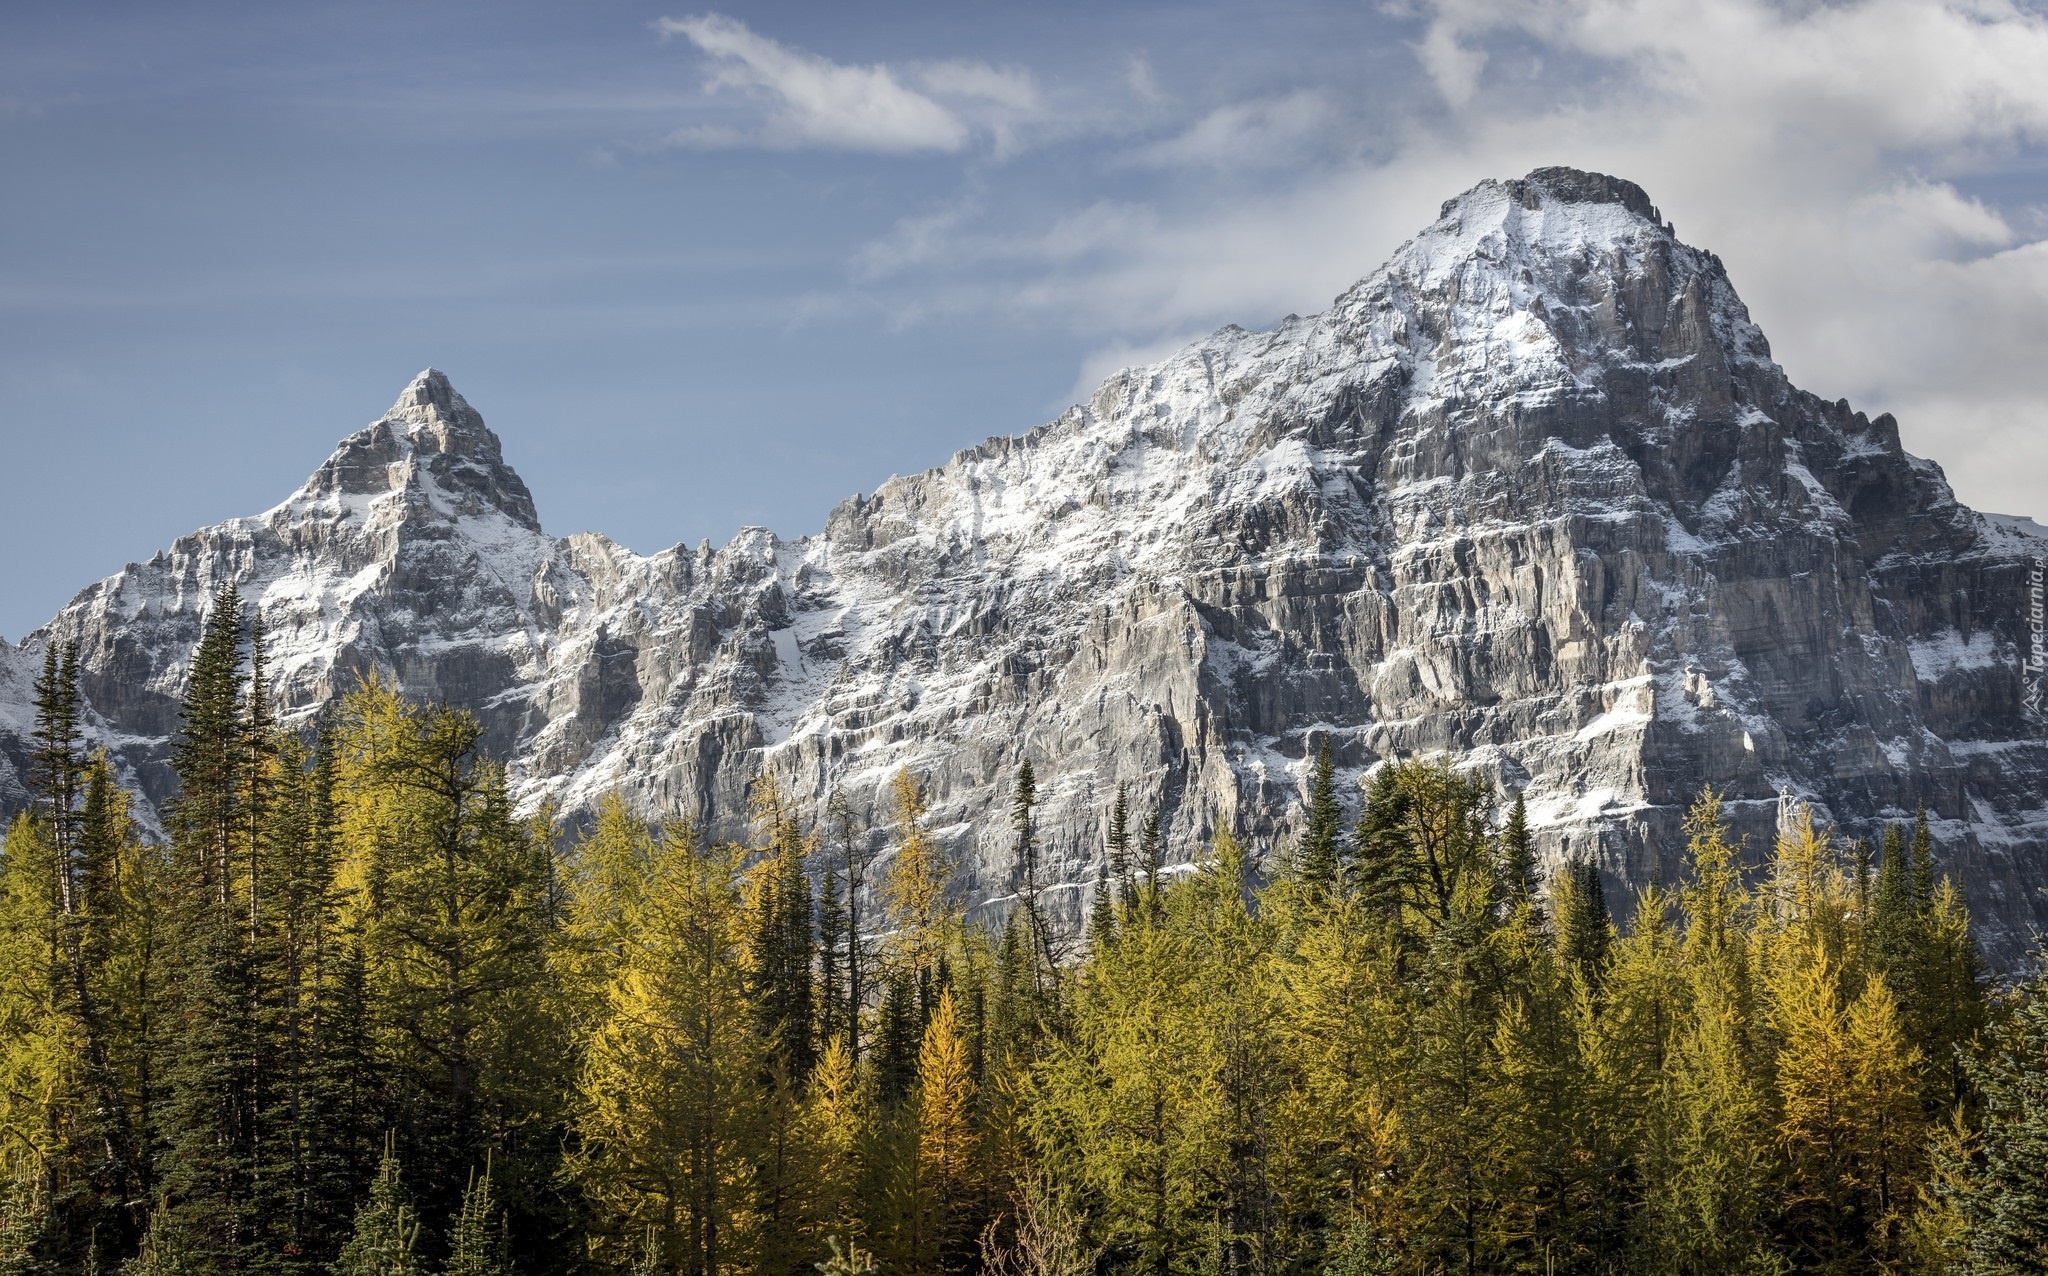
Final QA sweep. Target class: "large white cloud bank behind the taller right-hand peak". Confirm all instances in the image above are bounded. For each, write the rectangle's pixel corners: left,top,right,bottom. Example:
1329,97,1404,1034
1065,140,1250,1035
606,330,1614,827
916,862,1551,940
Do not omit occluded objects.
843,0,2048,516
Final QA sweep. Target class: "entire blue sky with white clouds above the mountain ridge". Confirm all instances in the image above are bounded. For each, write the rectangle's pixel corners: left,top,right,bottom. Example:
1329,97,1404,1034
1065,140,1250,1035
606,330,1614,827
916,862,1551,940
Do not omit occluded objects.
0,0,2048,637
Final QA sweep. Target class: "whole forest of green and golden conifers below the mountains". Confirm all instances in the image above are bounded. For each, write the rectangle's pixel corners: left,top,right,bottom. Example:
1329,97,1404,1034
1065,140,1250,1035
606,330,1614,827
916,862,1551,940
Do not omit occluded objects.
0,590,2048,1276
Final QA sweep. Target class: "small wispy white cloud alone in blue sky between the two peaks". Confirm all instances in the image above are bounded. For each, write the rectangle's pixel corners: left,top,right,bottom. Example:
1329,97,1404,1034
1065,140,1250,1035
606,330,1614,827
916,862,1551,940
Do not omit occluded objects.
655,12,1038,154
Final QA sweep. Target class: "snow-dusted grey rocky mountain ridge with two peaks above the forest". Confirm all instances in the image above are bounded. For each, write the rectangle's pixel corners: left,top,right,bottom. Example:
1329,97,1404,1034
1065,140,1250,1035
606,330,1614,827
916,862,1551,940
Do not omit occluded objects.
0,168,2048,961
